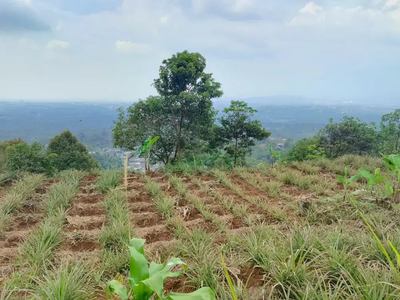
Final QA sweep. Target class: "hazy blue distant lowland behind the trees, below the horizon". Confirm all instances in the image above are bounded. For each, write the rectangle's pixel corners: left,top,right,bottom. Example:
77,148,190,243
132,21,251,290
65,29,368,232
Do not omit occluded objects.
0,97,394,147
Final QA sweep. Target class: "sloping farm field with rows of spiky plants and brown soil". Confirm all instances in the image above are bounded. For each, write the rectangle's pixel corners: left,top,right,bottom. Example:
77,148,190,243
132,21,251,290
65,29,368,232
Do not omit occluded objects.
0,156,400,300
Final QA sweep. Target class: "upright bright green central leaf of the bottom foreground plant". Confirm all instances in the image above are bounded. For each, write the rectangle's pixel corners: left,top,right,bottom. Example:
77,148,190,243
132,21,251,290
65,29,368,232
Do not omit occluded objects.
129,239,149,284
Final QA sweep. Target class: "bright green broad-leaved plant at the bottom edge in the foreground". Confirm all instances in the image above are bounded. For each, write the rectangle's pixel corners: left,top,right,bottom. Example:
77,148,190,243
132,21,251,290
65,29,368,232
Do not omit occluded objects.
106,238,215,300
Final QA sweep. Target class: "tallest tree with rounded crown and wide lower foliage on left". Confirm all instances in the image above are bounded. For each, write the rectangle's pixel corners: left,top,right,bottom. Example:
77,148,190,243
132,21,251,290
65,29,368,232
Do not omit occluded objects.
113,51,222,163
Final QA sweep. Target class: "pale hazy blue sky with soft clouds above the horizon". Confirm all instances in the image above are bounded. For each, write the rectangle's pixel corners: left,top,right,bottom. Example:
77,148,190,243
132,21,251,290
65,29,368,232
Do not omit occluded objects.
0,0,400,102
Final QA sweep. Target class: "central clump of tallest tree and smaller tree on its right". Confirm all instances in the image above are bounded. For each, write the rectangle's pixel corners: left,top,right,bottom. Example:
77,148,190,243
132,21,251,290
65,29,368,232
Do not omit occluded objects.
113,51,269,164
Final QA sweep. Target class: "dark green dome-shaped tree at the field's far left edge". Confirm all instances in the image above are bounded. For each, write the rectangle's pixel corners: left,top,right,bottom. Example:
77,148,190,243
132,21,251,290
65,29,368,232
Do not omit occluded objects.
47,130,99,171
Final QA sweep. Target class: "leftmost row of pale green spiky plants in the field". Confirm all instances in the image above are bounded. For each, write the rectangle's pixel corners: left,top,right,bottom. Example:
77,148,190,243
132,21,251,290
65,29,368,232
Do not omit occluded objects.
0,174,45,236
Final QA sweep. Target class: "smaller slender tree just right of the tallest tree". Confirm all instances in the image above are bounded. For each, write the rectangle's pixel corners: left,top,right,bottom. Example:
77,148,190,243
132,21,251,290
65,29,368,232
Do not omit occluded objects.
215,101,271,166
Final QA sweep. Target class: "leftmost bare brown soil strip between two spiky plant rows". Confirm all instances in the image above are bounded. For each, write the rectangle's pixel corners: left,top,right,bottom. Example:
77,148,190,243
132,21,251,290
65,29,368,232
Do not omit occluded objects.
0,180,55,282
